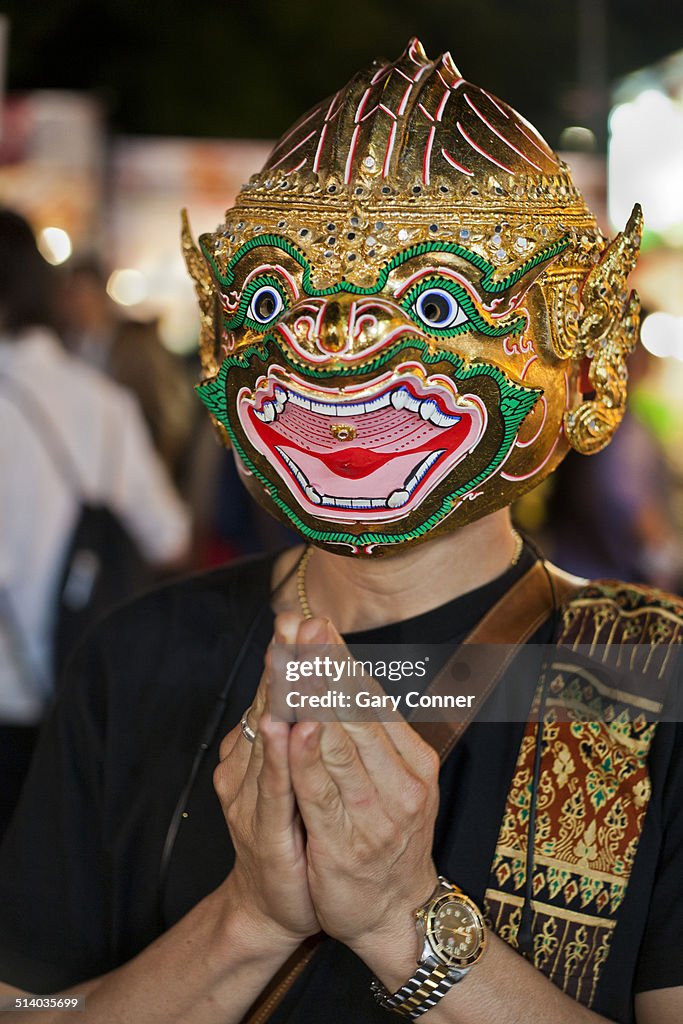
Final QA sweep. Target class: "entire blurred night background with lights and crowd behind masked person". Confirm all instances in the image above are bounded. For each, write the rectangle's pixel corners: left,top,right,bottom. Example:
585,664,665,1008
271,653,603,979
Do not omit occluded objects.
0,0,683,836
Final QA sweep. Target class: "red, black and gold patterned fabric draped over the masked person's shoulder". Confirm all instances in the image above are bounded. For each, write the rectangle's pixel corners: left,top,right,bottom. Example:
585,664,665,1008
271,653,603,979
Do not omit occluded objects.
485,583,683,1007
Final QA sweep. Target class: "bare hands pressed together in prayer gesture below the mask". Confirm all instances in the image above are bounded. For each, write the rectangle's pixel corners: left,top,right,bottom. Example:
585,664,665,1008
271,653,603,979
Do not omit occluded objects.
214,613,439,971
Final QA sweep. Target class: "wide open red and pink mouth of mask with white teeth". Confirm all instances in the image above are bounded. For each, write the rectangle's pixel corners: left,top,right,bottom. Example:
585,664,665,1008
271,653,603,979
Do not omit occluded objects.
238,367,486,521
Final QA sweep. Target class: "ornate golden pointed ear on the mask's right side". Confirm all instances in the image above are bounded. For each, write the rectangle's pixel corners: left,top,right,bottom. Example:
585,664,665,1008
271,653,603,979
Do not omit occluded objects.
564,204,643,455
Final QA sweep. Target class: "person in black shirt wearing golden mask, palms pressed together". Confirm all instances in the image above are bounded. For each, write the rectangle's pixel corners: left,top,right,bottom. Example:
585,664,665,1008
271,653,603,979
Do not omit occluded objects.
0,41,683,1024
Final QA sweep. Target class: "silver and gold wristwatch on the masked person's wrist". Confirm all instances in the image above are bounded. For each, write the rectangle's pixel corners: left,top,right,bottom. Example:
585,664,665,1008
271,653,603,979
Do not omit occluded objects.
371,876,486,1018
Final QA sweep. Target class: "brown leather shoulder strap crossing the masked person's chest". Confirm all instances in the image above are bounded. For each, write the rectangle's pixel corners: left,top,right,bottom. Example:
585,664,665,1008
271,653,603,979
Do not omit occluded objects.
242,560,586,1024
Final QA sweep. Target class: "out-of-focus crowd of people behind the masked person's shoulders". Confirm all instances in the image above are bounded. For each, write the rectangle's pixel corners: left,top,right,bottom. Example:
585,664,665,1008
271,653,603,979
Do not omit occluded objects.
0,201,683,836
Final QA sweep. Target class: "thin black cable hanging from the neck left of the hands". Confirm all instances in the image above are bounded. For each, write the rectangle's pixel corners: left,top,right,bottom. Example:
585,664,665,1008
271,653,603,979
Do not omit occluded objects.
157,559,300,930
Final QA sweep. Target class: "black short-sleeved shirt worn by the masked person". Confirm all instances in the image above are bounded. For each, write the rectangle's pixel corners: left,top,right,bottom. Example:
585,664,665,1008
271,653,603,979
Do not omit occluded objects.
0,552,683,1024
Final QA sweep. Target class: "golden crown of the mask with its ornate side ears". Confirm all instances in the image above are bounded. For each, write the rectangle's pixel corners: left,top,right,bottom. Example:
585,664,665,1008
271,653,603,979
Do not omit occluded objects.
183,40,642,454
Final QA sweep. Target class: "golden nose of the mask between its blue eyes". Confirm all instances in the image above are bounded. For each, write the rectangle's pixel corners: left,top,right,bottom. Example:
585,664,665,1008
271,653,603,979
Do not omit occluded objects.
279,292,420,362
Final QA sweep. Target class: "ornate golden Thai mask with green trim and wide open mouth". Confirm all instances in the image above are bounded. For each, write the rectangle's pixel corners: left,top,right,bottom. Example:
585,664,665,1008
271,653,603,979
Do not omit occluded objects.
183,40,641,555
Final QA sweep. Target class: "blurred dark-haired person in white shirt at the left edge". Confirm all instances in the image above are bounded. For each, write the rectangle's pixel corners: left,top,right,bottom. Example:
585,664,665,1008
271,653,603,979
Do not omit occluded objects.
0,210,189,834
